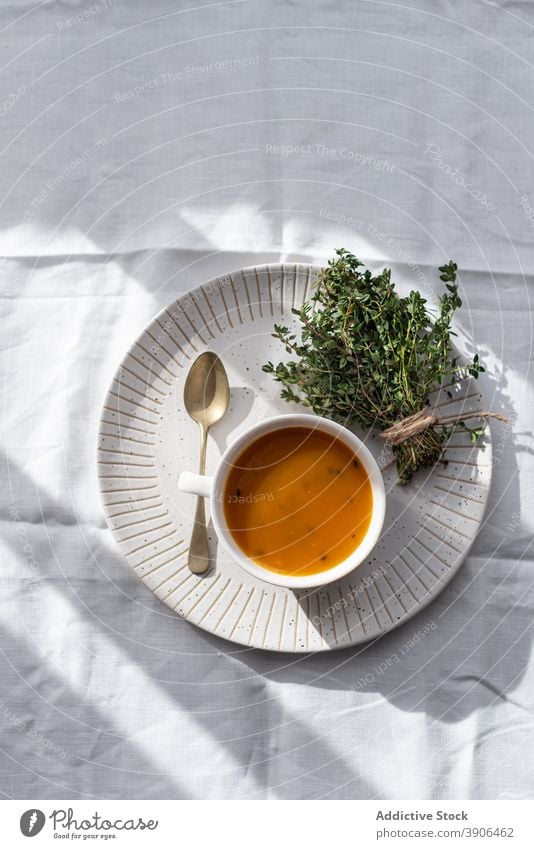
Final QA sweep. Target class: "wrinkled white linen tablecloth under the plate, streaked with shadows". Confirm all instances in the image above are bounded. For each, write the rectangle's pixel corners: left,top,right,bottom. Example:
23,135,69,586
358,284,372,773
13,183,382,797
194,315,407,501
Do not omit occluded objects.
0,0,534,799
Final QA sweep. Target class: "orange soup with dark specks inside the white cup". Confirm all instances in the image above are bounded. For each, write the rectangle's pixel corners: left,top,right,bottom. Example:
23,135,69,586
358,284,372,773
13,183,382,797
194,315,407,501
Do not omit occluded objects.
224,427,373,575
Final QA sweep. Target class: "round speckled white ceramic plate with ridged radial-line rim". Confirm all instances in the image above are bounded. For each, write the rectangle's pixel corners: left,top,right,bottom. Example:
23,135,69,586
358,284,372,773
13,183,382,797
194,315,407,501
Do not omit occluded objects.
98,264,491,652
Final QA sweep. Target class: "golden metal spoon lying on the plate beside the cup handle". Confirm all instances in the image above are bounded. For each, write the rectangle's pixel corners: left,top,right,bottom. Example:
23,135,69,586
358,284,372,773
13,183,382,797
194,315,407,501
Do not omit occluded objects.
184,351,230,575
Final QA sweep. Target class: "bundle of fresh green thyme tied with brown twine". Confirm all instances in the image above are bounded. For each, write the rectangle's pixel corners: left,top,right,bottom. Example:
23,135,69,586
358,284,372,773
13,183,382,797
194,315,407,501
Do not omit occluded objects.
263,250,508,484
